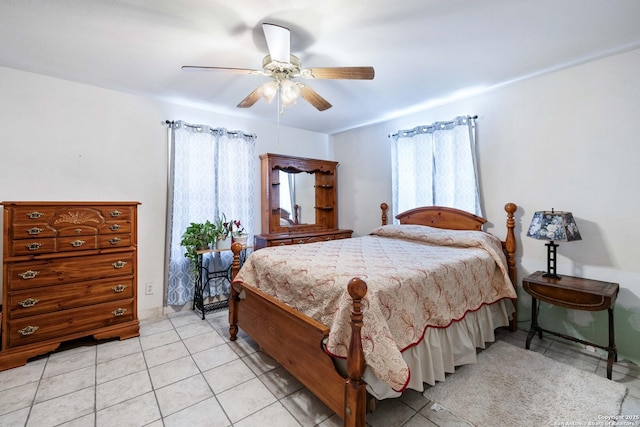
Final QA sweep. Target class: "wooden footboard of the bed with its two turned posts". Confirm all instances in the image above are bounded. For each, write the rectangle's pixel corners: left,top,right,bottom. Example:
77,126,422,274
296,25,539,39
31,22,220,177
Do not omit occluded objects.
229,244,367,426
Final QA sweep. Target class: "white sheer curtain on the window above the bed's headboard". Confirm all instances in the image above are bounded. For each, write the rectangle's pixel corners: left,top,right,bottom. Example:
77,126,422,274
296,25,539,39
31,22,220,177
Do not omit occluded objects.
390,116,482,222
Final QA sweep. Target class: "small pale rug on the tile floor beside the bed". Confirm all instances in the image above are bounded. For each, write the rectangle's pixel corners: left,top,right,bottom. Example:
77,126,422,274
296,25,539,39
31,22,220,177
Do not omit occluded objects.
424,341,627,427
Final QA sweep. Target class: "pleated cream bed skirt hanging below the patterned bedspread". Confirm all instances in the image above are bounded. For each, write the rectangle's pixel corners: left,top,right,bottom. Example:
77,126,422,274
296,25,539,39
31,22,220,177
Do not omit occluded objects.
334,299,514,400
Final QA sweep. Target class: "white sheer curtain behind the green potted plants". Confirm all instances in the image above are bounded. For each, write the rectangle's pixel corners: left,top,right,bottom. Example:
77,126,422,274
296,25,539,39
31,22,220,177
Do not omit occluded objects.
165,121,256,305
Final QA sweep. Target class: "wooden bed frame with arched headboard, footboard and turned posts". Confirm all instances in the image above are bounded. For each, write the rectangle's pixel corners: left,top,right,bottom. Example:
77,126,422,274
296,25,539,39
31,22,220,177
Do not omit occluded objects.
229,203,517,426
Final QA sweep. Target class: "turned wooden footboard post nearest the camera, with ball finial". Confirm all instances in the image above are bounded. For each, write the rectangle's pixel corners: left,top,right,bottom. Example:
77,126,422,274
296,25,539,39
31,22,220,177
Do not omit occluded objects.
343,277,367,427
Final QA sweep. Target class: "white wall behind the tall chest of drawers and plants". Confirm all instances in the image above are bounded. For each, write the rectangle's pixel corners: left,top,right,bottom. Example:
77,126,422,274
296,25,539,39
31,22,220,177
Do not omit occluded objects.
0,67,330,317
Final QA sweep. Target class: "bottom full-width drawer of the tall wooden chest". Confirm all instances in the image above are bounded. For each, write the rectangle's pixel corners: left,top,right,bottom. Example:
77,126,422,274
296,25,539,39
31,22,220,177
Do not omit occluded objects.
8,298,134,347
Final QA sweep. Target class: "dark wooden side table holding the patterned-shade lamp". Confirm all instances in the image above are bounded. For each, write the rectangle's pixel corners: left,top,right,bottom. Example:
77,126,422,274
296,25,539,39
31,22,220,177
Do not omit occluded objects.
522,271,620,379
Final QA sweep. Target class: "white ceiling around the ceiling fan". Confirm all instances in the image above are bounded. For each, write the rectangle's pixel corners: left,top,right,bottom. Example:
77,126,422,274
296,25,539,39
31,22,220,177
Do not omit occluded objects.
0,0,640,134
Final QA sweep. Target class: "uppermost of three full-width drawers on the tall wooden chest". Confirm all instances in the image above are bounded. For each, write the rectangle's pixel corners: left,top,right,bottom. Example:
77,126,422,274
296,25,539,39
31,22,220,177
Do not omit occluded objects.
7,252,135,291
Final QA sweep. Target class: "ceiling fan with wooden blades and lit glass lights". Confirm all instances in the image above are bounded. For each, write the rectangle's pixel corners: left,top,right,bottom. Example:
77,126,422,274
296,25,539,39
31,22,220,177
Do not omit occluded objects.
182,23,375,111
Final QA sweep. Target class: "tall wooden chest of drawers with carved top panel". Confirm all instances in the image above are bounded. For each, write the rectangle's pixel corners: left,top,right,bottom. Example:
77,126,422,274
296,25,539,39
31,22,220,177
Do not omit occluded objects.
0,202,139,370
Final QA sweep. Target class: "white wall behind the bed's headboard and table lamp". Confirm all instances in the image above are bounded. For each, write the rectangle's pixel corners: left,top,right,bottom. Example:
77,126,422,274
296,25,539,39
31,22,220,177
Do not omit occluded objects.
332,50,640,361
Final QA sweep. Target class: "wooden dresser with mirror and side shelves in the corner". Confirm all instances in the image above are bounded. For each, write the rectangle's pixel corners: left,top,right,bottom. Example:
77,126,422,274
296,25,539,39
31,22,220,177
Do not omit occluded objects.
254,153,352,249
